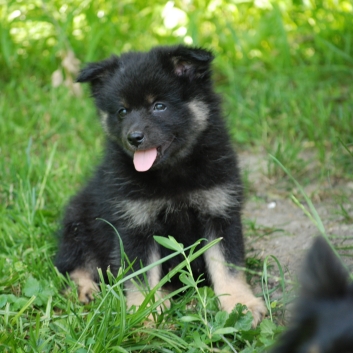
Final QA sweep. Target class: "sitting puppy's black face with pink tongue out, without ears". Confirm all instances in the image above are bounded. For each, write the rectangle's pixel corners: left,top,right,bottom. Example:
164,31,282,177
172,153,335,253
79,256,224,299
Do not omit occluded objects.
96,74,195,171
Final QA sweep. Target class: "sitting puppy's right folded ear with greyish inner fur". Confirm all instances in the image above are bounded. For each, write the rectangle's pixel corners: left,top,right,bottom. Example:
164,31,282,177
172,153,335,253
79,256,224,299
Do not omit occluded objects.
169,45,214,81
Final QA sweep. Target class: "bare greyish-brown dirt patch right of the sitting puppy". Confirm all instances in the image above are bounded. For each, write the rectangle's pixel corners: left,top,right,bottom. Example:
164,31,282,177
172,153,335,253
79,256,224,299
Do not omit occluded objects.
239,153,353,279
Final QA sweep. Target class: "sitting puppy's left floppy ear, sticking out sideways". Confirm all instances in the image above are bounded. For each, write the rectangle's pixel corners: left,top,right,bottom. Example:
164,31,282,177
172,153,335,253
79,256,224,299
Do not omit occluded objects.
76,55,119,87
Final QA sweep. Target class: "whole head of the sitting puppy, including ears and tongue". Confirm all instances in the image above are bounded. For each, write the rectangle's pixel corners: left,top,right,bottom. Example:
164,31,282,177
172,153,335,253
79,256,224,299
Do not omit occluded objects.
77,45,218,171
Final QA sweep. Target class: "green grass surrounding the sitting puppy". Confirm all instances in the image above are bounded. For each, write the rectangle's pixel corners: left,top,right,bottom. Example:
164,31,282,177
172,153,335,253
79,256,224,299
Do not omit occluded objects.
0,0,353,353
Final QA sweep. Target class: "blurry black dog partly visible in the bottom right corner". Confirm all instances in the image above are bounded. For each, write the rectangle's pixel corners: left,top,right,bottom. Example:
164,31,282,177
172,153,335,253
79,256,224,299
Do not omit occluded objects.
272,237,353,353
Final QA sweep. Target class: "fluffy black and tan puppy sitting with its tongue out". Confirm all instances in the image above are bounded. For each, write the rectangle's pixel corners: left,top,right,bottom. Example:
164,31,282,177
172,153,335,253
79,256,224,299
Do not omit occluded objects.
56,46,265,325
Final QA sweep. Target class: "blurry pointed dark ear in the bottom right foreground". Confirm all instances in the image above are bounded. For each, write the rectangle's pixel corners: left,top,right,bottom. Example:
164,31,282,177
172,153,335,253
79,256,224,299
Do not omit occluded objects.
301,237,349,299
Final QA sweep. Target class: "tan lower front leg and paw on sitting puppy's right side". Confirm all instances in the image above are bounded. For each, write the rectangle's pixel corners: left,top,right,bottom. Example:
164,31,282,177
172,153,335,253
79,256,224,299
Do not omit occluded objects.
204,244,267,327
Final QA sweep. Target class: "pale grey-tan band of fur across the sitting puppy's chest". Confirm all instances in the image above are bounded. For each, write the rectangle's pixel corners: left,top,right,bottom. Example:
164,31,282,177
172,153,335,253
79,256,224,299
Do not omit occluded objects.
114,185,240,227
